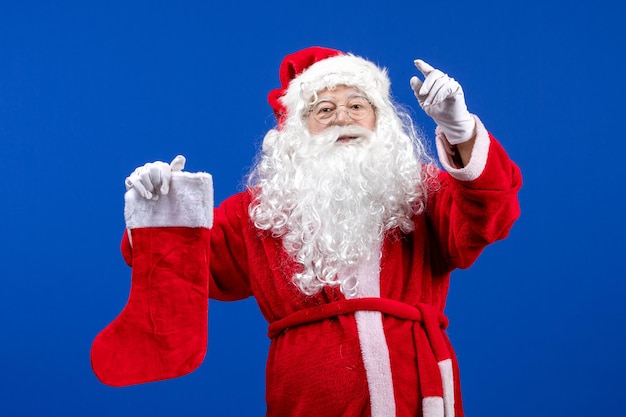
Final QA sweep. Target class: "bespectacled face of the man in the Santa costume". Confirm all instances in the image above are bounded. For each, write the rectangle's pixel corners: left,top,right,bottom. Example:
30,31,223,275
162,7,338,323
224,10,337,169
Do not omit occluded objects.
306,85,376,136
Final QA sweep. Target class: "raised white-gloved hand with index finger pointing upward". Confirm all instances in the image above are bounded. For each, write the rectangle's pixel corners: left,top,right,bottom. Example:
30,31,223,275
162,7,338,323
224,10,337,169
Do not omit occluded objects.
410,59,476,145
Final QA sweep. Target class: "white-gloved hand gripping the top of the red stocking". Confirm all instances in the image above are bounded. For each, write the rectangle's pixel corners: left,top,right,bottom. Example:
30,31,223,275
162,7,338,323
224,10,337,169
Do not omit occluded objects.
124,155,186,200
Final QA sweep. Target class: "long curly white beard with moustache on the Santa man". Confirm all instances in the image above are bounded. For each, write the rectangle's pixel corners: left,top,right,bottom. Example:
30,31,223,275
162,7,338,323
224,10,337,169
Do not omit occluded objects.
250,120,425,295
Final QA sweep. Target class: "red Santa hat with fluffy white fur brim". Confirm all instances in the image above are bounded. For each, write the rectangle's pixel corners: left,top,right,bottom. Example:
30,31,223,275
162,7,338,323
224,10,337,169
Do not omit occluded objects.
268,46,391,128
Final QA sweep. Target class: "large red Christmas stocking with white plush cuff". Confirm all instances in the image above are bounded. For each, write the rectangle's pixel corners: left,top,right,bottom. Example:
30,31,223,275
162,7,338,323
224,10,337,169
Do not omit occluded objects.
91,172,213,386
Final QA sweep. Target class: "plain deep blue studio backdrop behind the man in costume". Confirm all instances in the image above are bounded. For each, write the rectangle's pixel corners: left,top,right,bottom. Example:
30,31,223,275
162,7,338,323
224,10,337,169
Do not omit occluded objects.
0,0,626,417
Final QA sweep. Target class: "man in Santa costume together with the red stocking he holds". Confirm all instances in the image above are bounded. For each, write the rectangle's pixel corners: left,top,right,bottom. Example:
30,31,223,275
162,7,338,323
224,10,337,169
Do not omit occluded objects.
92,47,521,417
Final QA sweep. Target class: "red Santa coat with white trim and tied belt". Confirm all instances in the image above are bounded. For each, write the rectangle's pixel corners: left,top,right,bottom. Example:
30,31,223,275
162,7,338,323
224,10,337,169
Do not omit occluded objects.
108,117,521,417
